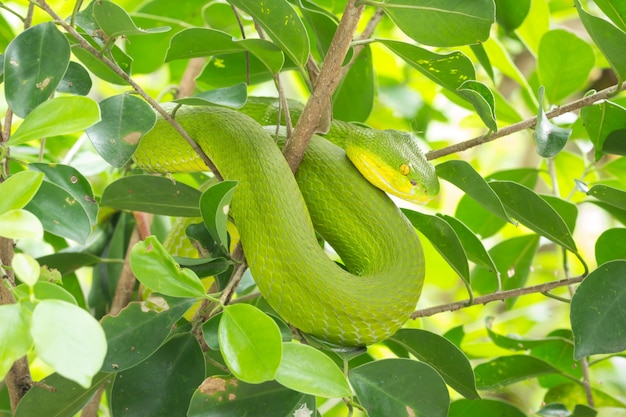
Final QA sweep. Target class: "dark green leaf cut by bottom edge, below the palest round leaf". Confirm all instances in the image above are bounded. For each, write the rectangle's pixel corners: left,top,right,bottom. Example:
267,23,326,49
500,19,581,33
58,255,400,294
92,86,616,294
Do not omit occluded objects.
15,372,113,417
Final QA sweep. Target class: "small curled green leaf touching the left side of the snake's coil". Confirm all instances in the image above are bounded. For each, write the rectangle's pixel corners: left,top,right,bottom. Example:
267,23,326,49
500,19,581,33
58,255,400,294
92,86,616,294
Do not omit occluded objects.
200,181,238,249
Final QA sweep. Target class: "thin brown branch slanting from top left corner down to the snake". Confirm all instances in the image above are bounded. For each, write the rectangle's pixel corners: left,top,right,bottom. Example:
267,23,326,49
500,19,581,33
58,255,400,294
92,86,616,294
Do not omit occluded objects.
37,0,222,180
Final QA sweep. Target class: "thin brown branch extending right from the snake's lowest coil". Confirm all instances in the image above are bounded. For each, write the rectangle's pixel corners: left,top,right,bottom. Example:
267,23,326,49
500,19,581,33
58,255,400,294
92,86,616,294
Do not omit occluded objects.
411,275,585,319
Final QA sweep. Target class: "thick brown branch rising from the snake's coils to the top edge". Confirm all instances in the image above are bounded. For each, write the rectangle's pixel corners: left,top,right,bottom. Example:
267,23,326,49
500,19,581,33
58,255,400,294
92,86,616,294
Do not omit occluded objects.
283,0,365,172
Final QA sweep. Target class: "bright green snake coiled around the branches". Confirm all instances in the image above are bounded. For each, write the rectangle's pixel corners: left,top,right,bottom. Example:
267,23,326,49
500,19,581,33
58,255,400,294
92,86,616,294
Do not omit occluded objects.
134,98,439,346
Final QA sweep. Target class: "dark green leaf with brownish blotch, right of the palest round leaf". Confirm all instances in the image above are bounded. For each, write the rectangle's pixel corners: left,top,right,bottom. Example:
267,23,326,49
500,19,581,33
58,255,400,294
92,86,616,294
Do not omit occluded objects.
102,298,195,372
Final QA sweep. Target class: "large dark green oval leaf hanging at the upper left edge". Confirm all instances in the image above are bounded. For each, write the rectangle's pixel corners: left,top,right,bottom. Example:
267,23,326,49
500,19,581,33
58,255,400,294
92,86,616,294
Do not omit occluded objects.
4,22,69,118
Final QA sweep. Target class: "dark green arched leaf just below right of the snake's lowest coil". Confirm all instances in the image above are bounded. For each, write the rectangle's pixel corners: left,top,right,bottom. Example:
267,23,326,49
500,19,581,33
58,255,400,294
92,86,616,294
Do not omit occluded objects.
389,329,479,399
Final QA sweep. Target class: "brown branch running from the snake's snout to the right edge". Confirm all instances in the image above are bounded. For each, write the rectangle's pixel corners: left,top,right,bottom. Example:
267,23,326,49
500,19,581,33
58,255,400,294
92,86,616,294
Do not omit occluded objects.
426,83,626,160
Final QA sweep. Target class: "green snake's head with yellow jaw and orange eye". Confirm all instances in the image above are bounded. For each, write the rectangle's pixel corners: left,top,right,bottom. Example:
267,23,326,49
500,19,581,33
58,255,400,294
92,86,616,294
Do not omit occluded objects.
346,129,439,204
